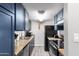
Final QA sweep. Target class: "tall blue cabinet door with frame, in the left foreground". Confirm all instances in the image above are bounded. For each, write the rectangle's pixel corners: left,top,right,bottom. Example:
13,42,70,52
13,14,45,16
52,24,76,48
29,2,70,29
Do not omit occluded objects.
0,5,14,56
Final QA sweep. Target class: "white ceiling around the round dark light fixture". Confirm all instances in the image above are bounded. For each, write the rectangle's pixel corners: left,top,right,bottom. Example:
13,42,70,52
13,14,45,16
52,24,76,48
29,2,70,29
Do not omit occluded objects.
23,3,64,21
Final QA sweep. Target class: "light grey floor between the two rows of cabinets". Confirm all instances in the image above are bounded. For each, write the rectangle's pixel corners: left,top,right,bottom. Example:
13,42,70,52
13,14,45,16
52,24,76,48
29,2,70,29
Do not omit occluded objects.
31,46,49,56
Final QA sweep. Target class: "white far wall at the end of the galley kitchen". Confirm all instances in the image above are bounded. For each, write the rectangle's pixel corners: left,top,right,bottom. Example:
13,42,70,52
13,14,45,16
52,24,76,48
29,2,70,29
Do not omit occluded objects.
31,19,54,46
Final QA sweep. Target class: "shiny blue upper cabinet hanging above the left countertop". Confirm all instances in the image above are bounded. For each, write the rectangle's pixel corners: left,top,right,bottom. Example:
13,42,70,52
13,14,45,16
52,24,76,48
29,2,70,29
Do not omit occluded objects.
15,3,25,31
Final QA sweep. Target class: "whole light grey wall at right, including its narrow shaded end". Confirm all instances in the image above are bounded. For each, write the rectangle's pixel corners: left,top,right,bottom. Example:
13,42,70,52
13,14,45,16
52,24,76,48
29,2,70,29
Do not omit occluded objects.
64,3,79,56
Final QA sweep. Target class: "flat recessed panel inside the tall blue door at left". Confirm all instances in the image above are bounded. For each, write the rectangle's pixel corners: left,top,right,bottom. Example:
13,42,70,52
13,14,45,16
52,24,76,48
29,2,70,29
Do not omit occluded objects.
0,11,12,56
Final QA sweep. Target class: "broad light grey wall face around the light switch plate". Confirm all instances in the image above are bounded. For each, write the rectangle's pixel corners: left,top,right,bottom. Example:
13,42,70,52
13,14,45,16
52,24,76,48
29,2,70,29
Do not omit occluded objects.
67,3,79,56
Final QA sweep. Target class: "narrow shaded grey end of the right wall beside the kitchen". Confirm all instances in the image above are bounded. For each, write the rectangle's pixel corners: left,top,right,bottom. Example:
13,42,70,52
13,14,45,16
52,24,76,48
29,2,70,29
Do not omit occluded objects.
64,4,68,56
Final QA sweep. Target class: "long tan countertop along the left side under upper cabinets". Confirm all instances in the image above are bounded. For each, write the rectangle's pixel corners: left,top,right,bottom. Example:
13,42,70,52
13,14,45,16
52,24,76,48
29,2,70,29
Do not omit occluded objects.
15,36,33,55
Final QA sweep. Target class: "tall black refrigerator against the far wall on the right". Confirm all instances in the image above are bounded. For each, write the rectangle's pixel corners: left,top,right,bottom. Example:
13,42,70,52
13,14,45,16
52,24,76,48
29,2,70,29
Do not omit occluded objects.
44,25,56,51
